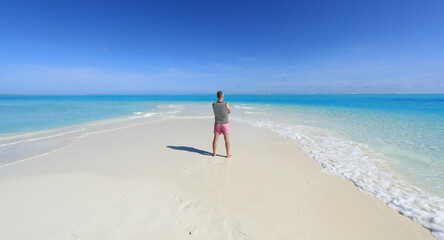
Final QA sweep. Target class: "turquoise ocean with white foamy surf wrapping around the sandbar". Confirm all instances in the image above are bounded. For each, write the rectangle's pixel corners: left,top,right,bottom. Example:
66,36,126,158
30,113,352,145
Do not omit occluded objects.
0,94,444,239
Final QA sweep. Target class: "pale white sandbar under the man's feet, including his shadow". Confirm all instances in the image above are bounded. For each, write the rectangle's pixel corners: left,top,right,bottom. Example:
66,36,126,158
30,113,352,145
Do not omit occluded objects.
0,117,434,240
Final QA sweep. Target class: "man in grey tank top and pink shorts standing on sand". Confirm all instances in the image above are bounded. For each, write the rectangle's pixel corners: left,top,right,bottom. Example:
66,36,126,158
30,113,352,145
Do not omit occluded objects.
213,91,232,158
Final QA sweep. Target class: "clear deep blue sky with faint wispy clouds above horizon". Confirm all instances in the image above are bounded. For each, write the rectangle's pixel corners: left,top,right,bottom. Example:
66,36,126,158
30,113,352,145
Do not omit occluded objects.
0,0,444,94
